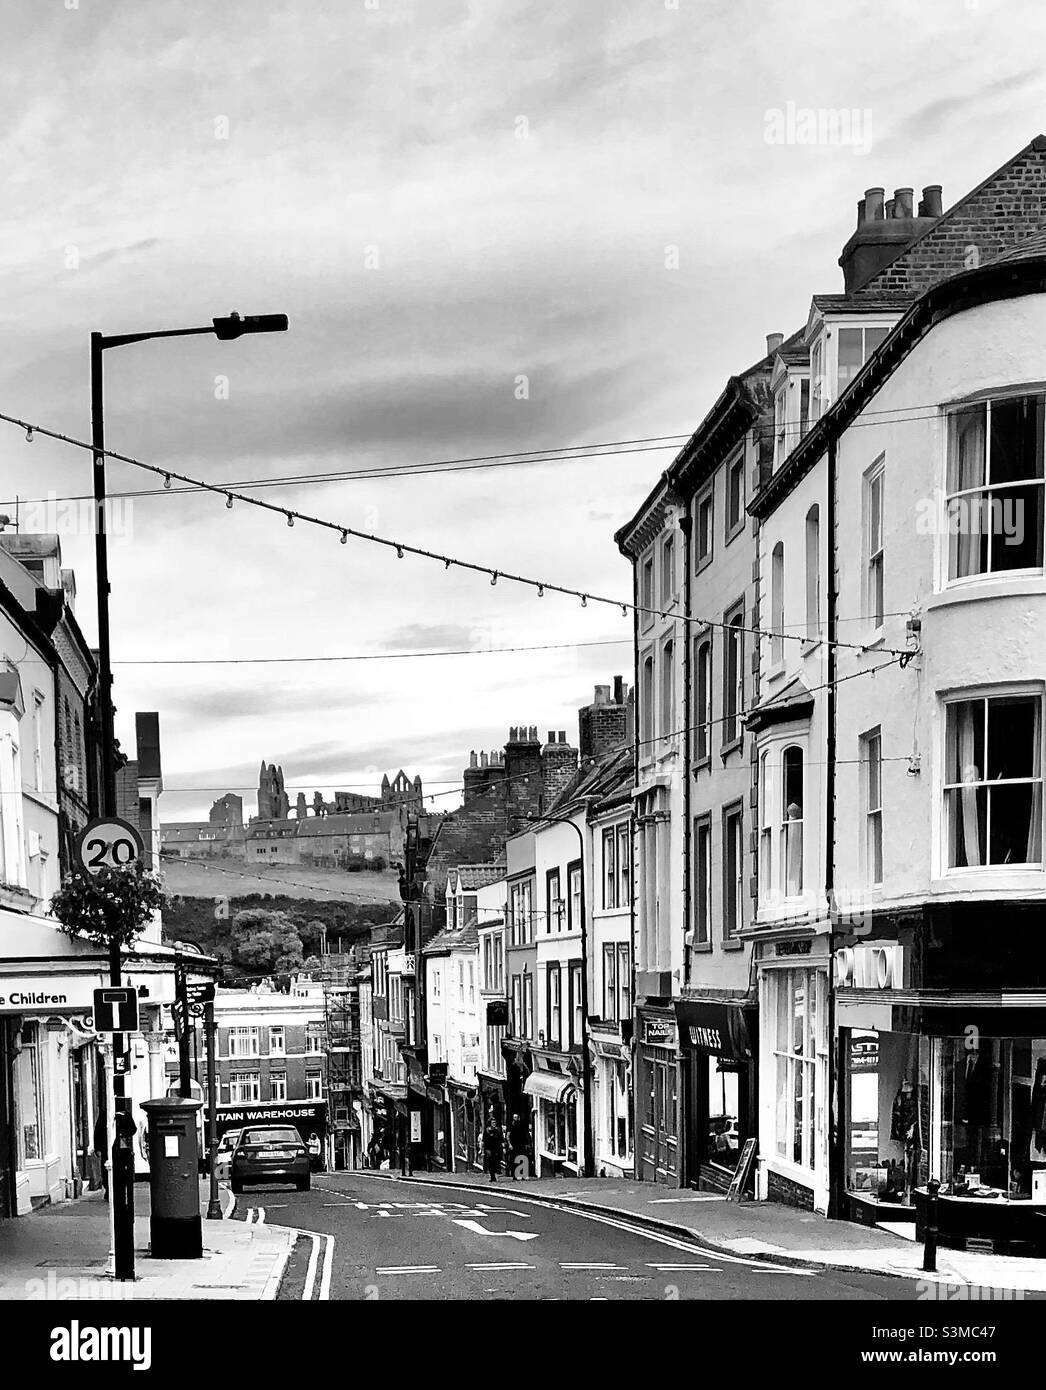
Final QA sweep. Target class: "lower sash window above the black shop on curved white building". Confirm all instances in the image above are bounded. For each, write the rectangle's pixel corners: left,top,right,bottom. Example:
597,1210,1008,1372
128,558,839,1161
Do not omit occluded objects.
943,694,1042,869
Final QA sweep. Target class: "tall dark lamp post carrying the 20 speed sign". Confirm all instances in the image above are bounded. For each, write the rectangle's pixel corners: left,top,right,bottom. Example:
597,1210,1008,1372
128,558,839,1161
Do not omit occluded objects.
90,313,288,1280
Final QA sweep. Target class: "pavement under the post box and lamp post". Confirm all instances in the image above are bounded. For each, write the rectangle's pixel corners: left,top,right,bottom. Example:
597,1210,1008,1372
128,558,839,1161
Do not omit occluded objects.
0,1182,296,1302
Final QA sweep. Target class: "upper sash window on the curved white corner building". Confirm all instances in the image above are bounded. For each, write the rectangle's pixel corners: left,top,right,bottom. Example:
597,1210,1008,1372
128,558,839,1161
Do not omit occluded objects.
946,395,1046,580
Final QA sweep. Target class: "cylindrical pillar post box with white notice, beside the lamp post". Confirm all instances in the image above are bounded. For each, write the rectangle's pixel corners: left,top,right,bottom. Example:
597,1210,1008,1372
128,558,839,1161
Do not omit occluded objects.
142,1095,203,1259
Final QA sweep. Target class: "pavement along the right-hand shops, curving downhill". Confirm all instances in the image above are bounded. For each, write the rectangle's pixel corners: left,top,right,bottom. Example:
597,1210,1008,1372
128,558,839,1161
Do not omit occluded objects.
371,1172,1046,1293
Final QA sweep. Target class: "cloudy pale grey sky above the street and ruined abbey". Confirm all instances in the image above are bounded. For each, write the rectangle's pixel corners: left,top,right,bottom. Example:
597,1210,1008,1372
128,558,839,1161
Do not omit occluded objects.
0,0,1046,820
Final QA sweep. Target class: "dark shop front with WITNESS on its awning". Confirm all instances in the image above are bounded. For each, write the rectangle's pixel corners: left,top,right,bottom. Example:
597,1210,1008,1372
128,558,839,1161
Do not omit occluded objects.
675,998,758,1193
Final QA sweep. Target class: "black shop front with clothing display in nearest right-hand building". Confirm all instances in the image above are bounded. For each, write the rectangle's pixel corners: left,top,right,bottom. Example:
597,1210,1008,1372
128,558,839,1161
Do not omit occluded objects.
835,920,1046,1255
